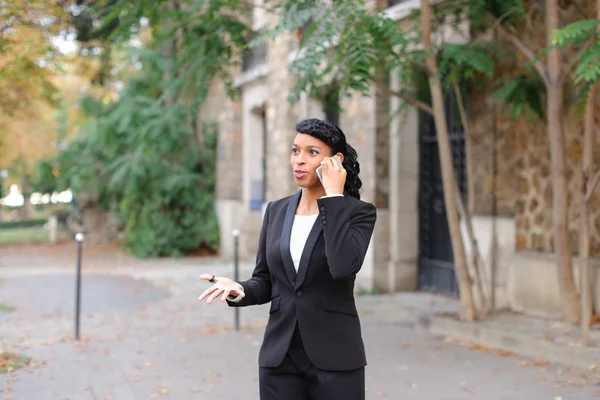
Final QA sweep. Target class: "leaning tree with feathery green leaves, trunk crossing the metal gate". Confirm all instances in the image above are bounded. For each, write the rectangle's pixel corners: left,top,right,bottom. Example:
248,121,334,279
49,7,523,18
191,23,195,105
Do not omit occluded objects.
266,0,506,320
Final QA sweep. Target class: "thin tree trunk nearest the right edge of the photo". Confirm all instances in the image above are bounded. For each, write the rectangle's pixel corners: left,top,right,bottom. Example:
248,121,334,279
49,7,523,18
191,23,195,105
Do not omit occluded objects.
579,81,600,346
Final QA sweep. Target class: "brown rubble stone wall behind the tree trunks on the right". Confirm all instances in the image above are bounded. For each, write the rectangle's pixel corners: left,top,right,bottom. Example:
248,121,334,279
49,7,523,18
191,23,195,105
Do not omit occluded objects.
469,1,600,257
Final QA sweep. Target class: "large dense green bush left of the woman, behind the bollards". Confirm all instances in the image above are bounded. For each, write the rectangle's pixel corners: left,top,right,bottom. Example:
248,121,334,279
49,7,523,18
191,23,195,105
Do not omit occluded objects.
58,54,218,257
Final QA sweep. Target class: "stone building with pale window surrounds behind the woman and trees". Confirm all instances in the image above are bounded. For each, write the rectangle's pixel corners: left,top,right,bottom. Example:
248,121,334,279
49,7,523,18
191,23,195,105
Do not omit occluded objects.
202,0,600,317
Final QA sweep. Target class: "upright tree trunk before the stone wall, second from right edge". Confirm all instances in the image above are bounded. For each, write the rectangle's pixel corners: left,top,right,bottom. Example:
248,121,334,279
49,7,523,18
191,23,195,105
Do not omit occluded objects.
546,0,580,323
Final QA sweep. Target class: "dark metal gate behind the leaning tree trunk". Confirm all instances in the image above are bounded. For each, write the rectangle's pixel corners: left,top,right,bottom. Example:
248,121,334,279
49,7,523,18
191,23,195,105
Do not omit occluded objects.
419,94,467,295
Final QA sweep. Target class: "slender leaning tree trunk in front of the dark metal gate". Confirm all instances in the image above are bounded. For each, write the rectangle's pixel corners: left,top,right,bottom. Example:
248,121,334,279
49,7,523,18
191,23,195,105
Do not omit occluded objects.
421,0,476,321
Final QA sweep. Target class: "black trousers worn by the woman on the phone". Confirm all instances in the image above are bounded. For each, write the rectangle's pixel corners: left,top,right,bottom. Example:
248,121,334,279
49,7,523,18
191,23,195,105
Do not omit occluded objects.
259,326,365,400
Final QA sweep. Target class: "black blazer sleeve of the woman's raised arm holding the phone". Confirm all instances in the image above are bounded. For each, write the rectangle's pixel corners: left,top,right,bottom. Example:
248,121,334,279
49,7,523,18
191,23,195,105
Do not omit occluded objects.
317,197,377,279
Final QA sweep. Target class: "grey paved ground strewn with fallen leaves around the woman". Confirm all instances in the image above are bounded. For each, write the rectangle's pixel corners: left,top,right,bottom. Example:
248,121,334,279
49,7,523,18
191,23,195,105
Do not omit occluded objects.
0,245,600,400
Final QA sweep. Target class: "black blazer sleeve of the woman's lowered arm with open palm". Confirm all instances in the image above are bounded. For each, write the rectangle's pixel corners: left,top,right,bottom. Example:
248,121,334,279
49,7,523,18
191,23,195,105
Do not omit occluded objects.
227,203,272,307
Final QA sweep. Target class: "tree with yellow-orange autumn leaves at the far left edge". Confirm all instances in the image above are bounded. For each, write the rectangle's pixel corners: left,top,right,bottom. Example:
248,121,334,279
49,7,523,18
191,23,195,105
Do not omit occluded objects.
0,0,68,217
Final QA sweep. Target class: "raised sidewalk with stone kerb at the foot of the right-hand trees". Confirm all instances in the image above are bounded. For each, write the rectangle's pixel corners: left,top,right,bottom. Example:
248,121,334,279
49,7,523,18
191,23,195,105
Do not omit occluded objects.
359,293,600,371
